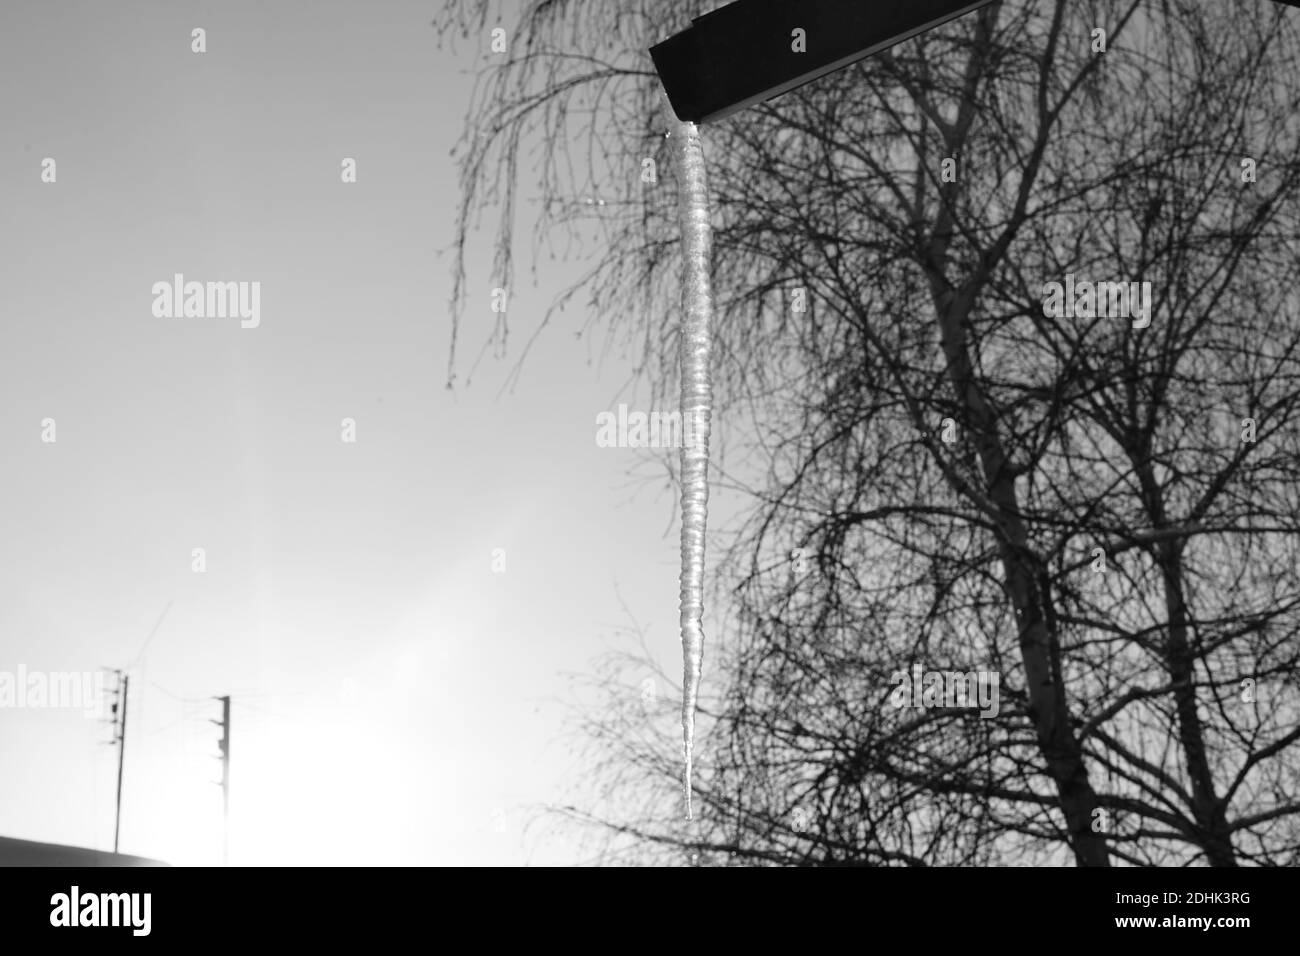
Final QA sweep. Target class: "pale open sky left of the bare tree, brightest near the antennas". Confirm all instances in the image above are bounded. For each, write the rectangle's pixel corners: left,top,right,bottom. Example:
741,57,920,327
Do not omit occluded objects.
0,0,707,864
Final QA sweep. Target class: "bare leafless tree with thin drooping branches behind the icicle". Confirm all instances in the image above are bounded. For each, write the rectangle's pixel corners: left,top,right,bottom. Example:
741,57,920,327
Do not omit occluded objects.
445,0,1300,866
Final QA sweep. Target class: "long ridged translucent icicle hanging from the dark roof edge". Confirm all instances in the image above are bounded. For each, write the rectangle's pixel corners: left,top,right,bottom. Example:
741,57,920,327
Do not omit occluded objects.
660,92,714,819
